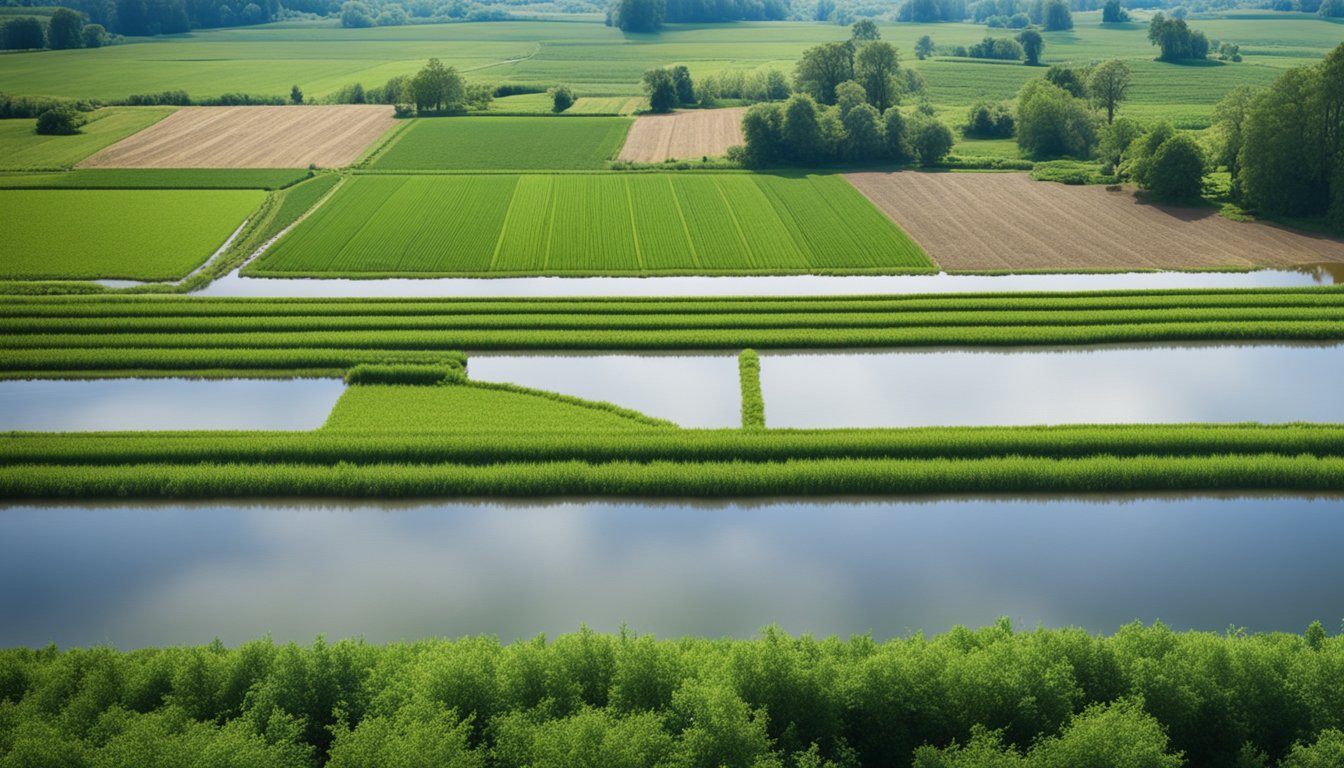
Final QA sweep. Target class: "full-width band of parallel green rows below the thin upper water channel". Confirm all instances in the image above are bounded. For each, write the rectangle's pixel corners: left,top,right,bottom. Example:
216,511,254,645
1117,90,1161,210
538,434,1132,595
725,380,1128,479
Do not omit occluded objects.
0,287,1344,378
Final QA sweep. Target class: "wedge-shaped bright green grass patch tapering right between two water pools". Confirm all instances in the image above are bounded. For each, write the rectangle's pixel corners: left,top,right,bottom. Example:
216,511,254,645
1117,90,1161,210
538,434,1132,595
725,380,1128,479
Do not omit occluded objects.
324,382,671,436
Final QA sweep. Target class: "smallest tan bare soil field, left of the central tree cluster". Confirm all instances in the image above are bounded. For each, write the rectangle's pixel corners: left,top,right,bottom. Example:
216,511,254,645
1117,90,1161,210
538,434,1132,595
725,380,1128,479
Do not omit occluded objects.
617,108,746,163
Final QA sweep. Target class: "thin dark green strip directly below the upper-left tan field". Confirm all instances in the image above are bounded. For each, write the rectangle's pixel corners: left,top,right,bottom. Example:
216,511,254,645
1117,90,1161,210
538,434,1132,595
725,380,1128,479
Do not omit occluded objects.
0,168,308,190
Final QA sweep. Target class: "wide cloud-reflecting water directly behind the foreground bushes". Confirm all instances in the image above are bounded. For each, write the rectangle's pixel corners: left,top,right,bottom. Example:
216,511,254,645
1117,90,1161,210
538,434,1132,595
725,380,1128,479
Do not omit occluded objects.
0,498,1344,648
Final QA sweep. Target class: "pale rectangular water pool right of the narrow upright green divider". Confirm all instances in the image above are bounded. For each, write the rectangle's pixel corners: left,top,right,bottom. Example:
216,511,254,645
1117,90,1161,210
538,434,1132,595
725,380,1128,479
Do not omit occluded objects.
761,344,1344,428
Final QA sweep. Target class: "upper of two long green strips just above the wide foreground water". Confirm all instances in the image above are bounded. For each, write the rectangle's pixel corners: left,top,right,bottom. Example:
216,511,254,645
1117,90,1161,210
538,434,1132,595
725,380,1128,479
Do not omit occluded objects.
0,425,1344,465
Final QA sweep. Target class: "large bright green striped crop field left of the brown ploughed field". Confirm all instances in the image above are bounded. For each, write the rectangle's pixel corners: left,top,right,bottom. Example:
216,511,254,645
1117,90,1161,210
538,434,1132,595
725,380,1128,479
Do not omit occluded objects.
249,172,931,277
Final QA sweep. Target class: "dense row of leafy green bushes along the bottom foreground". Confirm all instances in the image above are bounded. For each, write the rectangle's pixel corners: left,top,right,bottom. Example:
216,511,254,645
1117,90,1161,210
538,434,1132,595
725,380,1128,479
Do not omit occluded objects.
0,619,1344,768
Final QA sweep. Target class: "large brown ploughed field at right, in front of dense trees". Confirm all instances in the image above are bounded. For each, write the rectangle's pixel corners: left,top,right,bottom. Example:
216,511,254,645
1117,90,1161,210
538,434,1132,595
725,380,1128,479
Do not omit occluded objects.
847,171,1344,272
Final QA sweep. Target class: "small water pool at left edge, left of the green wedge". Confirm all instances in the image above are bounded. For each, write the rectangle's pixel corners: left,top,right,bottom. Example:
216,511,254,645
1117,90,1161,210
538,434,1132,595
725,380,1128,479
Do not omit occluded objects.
0,379,345,432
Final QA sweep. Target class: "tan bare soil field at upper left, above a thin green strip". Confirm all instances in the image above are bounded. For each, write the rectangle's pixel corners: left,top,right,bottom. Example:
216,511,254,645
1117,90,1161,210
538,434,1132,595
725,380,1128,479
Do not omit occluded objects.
78,105,395,168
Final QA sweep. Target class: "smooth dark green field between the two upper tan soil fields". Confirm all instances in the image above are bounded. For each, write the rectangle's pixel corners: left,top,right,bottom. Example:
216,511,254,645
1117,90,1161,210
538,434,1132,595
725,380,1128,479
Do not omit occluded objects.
368,114,630,171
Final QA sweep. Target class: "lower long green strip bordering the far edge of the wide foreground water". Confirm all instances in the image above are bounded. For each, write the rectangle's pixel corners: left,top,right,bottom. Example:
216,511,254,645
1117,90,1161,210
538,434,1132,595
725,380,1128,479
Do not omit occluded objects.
0,453,1344,499
